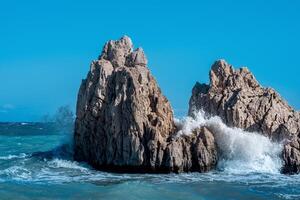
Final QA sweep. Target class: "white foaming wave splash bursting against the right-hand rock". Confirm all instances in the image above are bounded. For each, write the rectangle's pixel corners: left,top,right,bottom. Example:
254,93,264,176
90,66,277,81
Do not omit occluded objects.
176,111,282,174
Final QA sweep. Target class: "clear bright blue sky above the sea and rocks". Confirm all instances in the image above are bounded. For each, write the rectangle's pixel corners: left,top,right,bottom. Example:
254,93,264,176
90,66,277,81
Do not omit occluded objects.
0,0,300,121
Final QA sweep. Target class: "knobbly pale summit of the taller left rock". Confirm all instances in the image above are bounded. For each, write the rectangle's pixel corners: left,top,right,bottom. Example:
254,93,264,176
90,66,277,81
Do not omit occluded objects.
99,35,148,68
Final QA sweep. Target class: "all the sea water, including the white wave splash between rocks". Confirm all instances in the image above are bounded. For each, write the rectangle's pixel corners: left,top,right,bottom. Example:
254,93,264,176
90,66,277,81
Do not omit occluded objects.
0,116,300,200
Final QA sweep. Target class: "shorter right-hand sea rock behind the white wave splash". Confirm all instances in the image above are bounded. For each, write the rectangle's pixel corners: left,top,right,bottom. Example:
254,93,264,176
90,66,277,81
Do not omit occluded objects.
189,60,300,173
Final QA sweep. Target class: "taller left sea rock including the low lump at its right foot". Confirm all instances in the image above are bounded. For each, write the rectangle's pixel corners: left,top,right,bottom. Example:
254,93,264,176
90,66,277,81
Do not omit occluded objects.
74,36,217,172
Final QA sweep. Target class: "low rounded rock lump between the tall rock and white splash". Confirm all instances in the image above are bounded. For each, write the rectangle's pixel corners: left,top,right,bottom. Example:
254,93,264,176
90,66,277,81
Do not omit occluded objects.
164,127,218,172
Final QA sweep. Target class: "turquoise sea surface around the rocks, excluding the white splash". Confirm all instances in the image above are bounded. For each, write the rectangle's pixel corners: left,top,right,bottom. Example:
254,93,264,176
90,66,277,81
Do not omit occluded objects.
0,124,300,200
